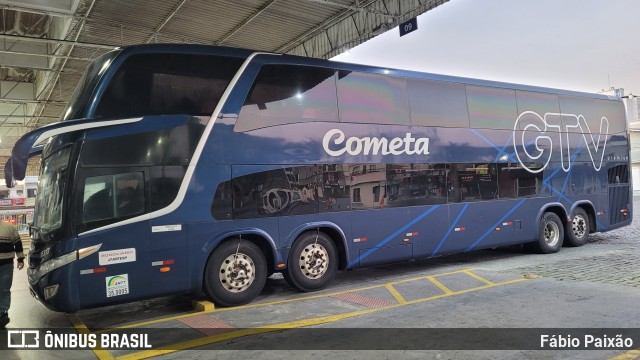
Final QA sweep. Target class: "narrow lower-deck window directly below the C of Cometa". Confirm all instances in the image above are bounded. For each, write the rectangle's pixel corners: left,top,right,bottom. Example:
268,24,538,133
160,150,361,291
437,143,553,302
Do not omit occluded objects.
319,165,351,212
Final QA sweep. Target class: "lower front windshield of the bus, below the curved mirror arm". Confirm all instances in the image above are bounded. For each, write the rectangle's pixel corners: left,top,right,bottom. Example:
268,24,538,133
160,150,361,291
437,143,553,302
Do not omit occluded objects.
33,146,71,236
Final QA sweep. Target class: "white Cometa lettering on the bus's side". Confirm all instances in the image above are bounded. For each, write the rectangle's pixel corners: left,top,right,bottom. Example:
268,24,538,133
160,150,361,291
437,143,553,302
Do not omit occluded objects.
322,129,429,156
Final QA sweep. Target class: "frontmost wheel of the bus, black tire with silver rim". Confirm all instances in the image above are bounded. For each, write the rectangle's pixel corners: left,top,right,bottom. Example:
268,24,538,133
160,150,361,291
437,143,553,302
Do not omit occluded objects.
204,239,267,306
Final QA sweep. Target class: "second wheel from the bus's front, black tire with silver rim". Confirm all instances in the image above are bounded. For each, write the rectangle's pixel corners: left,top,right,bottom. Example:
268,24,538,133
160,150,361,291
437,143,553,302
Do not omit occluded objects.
282,231,338,292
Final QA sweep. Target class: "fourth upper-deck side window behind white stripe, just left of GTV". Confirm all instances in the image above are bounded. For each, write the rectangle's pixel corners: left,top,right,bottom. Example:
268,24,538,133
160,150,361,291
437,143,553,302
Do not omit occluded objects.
467,85,518,130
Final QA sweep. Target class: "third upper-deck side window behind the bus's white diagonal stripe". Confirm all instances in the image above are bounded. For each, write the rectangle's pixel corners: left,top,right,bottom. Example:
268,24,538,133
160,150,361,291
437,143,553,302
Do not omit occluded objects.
407,79,469,128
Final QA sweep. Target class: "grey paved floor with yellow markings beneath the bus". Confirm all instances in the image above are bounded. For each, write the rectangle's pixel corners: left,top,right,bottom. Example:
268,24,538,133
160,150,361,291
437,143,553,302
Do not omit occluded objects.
0,198,640,359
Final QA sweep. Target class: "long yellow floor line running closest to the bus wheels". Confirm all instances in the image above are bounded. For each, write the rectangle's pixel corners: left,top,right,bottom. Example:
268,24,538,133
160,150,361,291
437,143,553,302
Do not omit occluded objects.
95,269,473,334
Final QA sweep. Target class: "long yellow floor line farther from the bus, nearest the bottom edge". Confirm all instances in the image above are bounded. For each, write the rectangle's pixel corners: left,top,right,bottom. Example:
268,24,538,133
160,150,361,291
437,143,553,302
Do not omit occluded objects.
117,278,527,360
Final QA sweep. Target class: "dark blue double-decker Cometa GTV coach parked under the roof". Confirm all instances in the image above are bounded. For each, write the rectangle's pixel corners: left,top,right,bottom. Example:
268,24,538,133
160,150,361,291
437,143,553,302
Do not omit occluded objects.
5,44,632,312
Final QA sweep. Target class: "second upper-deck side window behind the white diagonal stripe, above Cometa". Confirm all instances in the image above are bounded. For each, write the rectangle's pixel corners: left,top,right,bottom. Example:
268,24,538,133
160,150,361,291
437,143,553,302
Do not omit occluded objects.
338,70,409,125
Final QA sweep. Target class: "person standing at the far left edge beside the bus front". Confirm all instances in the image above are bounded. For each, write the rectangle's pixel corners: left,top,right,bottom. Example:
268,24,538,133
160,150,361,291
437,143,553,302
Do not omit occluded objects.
0,221,24,328
